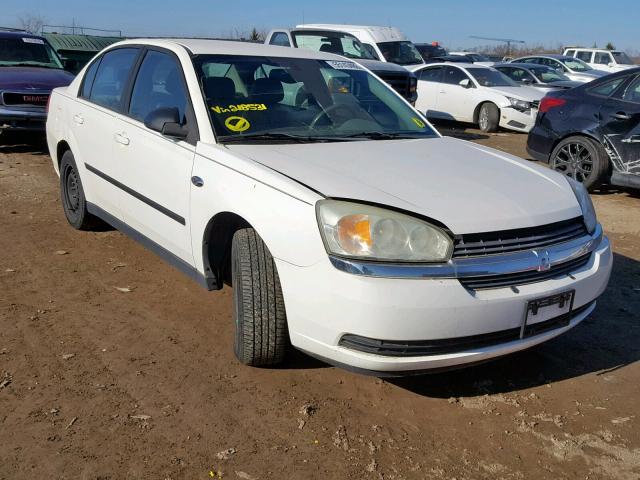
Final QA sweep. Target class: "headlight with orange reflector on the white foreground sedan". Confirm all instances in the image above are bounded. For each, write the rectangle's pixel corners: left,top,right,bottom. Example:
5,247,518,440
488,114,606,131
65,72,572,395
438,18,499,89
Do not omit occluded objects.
317,200,453,262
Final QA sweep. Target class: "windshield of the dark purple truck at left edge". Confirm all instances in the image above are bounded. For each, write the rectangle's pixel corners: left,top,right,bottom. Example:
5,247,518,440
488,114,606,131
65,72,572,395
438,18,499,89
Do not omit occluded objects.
0,37,62,69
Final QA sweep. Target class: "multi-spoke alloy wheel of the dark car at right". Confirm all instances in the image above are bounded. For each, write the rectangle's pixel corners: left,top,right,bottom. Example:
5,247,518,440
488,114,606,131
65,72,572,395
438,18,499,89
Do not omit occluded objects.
549,135,609,190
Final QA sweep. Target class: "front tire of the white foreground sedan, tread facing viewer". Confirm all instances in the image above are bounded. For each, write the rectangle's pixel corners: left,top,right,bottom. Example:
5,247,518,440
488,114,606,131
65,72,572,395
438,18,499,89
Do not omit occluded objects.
231,228,289,366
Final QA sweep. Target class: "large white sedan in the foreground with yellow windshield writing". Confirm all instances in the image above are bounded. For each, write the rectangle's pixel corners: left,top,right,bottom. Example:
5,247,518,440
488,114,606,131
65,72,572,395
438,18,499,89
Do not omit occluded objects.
47,39,612,375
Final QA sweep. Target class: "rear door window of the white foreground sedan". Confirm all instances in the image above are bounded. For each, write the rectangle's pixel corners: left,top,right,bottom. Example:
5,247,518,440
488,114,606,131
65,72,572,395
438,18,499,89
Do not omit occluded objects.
89,48,138,111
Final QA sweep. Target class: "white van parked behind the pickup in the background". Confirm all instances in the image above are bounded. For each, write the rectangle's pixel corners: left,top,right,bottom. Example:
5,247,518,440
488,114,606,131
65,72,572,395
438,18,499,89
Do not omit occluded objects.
296,23,424,68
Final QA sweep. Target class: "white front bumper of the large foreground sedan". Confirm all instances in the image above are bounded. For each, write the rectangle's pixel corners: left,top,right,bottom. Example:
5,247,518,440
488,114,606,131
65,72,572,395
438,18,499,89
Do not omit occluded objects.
276,231,612,374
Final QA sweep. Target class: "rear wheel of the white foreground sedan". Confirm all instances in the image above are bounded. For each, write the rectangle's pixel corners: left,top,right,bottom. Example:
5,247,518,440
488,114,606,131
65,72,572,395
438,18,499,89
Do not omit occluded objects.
60,150,100,230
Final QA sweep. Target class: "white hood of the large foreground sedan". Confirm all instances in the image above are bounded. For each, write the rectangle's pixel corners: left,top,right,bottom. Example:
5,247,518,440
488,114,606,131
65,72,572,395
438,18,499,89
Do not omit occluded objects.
227,137,581,234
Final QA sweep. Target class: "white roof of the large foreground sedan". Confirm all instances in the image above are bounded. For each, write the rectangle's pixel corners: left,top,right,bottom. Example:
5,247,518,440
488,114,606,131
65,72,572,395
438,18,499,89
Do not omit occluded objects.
104,38,344,60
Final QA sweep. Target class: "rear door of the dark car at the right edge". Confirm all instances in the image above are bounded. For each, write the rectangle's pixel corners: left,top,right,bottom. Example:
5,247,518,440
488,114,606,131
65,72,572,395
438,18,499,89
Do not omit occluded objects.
600,75,640,175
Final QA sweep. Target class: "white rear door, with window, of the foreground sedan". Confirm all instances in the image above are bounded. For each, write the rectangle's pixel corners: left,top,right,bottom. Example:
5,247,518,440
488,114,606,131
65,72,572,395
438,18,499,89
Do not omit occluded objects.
70,47,140,218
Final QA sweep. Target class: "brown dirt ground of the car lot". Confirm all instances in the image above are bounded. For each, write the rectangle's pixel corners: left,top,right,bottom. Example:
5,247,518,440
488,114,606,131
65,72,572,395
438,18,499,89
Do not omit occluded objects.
0,125,640,480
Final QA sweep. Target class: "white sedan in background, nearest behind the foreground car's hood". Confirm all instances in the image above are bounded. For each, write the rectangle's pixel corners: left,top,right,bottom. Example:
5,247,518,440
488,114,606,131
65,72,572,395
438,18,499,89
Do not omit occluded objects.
414,63,544,132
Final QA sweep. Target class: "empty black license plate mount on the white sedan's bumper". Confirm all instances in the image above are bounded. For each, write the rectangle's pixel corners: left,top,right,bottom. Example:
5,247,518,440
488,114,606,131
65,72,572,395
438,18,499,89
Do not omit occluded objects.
520,290,576,338
